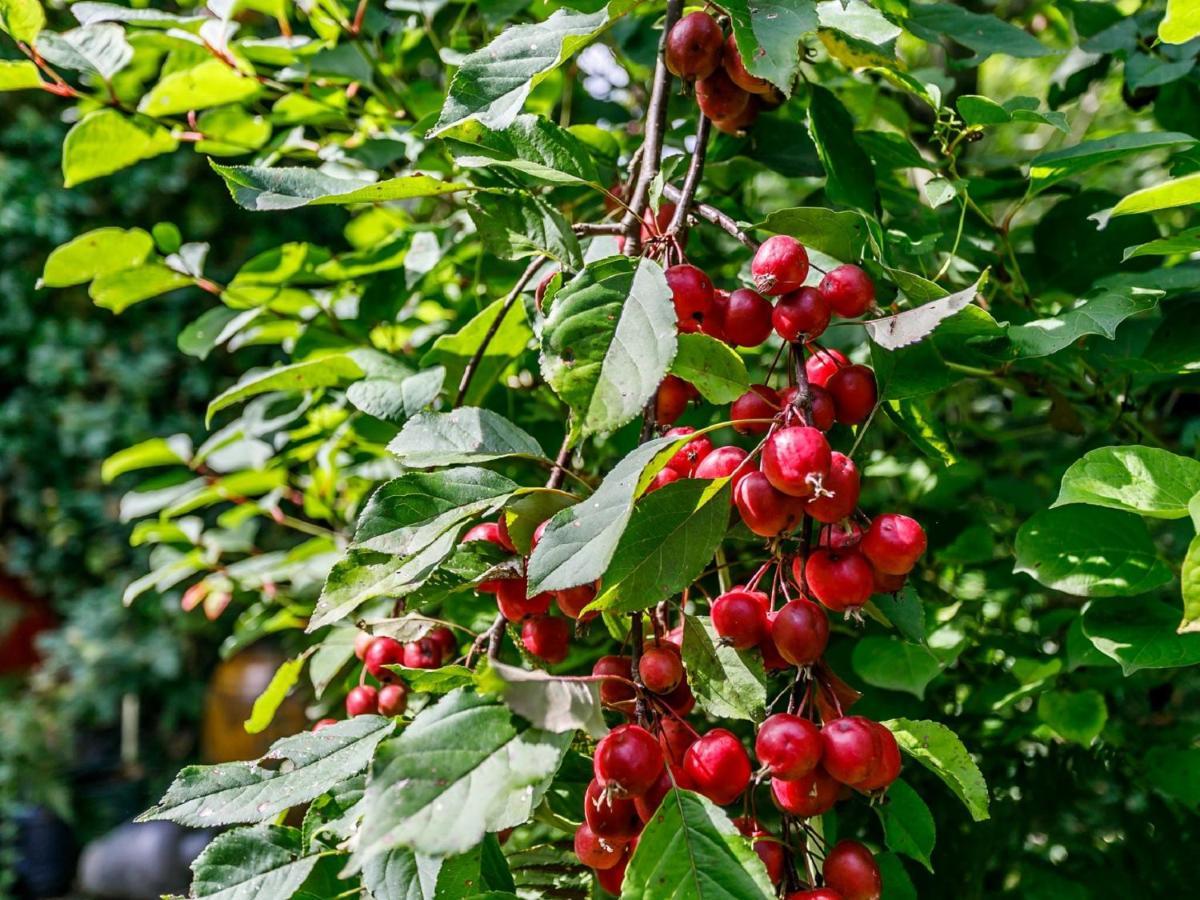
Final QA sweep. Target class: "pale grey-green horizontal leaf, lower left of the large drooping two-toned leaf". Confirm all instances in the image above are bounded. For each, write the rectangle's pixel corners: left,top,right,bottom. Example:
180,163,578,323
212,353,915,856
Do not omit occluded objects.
388,407,545,469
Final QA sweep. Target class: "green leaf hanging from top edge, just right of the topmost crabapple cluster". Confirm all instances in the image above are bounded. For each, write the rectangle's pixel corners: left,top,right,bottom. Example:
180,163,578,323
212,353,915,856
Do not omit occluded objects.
721,0,818,96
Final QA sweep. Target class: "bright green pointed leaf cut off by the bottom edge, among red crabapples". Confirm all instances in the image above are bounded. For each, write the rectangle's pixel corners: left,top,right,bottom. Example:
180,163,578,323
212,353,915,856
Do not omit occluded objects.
620,788,775,900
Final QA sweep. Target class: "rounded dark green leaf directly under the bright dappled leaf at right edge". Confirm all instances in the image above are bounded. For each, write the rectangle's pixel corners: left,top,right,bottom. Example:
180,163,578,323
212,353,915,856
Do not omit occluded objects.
1013,505,1171,596
